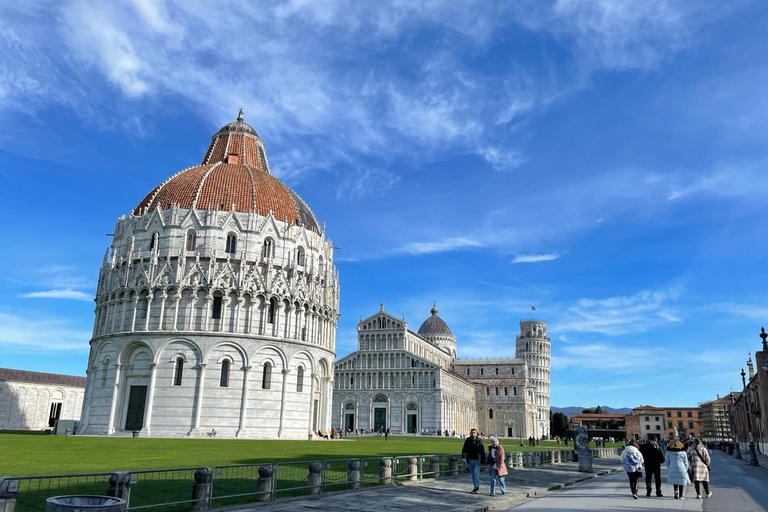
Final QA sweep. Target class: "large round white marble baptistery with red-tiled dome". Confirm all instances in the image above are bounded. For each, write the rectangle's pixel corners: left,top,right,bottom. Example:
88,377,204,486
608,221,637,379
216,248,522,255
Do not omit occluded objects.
78,111,339,439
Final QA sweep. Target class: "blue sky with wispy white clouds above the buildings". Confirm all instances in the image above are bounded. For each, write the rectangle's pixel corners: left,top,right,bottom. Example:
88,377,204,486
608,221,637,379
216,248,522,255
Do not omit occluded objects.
0,0,768,407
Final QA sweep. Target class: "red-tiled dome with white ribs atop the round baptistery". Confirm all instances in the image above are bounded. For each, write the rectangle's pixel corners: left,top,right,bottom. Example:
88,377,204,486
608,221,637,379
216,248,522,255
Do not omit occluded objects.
134,111,320,233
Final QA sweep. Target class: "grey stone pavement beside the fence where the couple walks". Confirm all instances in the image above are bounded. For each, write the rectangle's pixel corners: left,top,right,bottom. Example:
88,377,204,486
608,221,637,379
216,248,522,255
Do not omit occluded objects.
218,457,622,512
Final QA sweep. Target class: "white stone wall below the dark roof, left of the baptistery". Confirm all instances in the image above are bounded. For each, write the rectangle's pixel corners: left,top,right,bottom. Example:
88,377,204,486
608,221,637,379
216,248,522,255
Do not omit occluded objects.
0,381,84,430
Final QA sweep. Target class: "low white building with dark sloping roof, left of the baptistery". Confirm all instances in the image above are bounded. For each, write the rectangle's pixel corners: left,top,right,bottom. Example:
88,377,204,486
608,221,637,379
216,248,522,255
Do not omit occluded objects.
0,368,85,430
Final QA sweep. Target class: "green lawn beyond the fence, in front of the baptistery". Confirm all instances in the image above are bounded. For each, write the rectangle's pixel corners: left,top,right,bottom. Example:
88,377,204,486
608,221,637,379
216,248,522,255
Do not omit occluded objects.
0,432,620,476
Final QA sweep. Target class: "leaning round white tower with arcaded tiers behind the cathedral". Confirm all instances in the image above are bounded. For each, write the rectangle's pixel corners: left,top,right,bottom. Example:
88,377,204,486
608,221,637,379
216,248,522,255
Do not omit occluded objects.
515,320,552,437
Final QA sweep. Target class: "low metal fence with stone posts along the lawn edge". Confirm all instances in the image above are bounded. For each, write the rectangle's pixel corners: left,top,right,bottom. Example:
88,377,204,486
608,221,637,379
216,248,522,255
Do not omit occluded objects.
0,448,620,512
